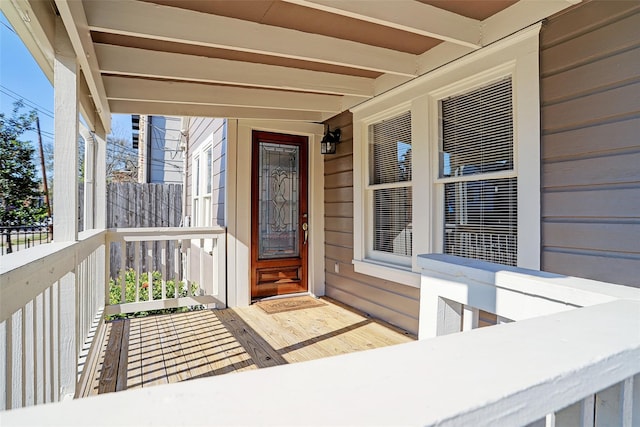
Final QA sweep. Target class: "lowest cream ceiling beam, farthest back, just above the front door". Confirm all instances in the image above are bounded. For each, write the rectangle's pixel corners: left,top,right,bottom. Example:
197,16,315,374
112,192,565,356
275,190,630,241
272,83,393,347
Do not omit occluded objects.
109,100,333,122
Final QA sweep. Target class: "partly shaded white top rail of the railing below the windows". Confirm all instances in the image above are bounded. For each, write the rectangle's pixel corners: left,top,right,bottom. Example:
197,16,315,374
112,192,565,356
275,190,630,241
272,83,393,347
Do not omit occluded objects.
418,254,640,307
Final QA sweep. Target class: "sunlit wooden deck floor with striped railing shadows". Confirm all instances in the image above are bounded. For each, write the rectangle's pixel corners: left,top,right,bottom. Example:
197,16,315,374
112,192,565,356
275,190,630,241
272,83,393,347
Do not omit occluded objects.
78,298,415,397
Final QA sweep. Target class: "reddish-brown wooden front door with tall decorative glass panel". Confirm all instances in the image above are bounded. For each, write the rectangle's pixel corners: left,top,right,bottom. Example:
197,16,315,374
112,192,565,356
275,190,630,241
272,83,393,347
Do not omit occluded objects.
251,131,308,299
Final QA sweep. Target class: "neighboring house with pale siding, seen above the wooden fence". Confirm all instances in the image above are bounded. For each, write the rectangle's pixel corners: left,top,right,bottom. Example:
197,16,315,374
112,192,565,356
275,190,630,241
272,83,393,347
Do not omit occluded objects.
131,114,184,184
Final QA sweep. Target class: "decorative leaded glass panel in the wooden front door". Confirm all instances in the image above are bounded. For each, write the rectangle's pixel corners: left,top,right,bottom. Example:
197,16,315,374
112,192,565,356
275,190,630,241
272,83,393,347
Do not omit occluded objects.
258,142,300,259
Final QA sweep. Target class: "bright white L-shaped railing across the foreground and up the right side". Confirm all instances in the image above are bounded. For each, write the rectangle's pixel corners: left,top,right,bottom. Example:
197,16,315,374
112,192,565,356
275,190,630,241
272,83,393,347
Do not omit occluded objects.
0,249,640,427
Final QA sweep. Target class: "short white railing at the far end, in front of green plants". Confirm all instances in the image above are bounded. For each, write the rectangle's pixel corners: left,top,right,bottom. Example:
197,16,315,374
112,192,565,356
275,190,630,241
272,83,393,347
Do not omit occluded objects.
105,227,226,315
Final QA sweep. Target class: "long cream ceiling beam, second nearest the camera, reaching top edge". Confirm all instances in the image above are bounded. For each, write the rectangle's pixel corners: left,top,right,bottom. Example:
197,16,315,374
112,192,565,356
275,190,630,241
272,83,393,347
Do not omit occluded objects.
84,0,416,76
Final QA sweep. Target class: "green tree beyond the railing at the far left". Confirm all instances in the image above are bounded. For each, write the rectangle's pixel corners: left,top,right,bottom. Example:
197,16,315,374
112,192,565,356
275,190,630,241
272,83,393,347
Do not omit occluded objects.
0,101,46,224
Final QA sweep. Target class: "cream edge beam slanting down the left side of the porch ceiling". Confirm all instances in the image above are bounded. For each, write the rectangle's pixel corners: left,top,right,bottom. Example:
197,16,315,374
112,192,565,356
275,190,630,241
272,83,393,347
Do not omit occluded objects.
56,0,111,132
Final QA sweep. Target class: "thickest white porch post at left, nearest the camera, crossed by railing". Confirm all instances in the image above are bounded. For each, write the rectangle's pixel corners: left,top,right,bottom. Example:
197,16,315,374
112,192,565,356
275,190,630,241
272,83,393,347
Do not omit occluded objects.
53,18,79,399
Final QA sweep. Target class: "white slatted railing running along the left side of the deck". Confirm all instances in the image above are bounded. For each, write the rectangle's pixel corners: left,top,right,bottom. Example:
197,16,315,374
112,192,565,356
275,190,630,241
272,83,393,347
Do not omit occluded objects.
0,230,105,409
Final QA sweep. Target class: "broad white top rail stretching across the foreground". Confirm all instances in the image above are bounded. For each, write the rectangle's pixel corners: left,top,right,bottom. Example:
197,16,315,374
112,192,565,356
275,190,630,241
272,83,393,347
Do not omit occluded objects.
3,301,640,426
